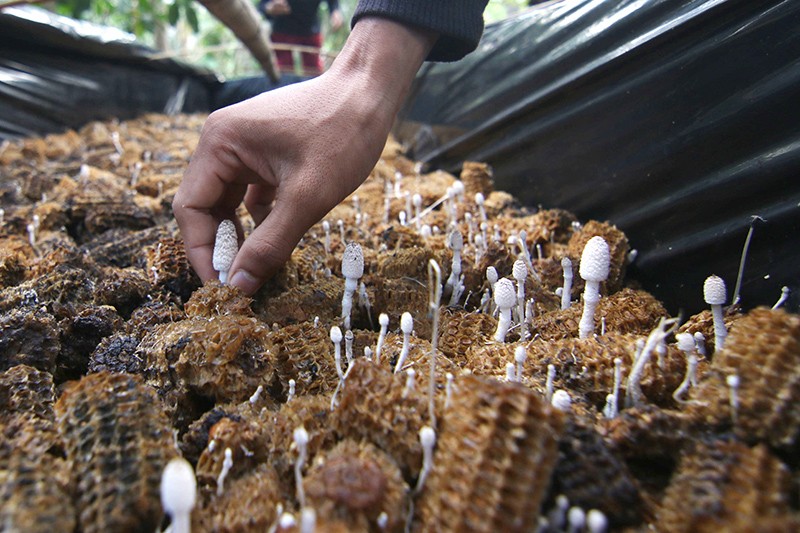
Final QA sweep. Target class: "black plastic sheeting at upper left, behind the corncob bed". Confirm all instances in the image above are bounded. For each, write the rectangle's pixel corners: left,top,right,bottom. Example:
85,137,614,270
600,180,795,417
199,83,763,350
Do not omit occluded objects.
0,6,221,139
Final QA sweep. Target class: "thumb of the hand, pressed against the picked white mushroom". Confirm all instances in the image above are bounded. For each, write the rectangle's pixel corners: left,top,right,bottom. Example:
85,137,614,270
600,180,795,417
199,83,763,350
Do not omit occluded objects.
230,198,310,295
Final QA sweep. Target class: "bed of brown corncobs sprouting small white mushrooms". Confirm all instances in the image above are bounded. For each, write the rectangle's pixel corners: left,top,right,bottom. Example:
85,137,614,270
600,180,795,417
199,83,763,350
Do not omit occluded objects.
0,111,800,532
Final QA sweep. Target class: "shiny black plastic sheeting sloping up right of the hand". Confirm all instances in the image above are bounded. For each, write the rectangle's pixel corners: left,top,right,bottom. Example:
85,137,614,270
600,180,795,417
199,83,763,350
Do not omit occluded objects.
397,0,800,313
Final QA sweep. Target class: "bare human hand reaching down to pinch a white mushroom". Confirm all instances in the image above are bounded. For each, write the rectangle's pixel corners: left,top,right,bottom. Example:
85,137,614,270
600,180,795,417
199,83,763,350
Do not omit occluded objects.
173,18,436,294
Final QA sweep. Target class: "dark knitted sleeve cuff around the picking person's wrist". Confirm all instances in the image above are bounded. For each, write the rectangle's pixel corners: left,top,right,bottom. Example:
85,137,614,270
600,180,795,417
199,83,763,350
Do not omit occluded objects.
351,0,488,61
